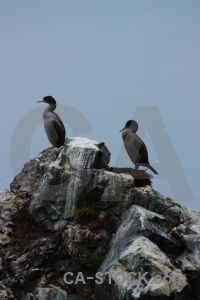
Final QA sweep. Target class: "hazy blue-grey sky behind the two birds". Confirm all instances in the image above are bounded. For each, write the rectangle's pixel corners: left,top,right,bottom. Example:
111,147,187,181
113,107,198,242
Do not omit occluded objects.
0,0,200,210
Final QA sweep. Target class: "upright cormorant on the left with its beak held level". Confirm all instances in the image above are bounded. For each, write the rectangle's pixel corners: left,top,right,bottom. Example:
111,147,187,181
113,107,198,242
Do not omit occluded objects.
37,96,66,148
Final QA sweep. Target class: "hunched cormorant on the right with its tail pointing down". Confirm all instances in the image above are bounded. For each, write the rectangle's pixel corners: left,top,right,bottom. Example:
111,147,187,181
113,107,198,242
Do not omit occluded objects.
120,120,158,174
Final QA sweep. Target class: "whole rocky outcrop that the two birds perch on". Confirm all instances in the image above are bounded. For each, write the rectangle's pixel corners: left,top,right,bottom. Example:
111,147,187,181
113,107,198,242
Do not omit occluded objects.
0,138,200,300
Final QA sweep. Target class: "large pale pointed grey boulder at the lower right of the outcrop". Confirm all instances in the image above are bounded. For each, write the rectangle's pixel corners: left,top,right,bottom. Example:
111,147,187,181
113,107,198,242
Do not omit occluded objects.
95,205,190,300
